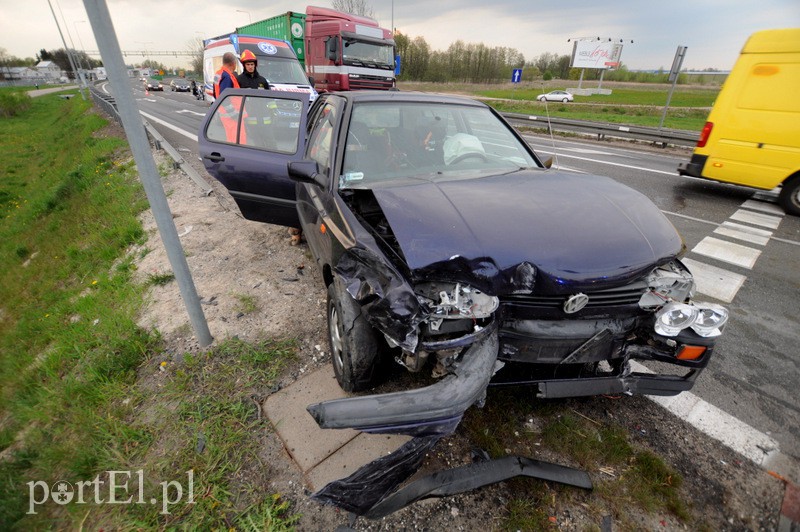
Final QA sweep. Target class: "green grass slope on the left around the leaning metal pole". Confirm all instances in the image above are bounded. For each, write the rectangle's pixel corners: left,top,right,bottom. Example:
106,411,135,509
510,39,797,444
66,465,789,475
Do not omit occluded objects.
0,90,295,530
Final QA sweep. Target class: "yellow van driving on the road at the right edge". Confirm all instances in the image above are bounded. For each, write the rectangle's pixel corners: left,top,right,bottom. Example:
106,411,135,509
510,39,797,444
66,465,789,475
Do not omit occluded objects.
678,28,800,216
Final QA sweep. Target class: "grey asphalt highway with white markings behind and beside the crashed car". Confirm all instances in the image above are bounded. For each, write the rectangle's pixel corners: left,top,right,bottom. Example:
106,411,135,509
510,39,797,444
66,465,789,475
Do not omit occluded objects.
98,78,800,470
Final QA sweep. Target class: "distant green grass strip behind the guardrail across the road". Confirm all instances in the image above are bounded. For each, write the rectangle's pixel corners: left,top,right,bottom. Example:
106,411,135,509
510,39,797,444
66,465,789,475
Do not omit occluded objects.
401,80,719,131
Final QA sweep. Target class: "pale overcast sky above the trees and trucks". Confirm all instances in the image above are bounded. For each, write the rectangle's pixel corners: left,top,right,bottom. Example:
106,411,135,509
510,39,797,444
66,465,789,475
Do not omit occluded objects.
0,0,800,70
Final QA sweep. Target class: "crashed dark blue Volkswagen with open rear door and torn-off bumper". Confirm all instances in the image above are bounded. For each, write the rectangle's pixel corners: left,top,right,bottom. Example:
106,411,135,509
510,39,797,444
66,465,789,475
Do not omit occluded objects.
199,90,728,517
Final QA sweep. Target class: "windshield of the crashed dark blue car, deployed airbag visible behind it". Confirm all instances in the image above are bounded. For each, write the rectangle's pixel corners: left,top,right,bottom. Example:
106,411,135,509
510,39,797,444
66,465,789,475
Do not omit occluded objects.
339,102,539,189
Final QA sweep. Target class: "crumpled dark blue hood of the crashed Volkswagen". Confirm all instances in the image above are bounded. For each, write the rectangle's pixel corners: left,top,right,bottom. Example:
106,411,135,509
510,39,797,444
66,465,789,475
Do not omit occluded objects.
373,170,683,292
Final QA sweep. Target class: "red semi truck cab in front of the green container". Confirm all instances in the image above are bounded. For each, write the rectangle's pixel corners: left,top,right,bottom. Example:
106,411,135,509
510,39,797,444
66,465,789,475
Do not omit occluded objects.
305,6,395,92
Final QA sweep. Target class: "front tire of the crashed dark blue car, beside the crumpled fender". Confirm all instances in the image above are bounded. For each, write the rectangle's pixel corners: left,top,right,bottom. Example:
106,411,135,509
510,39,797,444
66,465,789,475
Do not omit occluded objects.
327,277,391,392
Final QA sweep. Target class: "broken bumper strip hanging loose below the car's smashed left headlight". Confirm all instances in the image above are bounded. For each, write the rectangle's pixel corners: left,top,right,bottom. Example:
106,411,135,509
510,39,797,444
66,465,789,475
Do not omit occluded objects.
307,331,498,436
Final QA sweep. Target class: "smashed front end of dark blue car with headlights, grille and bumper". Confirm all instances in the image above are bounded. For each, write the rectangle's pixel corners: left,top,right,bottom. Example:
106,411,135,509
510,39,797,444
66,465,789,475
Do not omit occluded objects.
309,241,727,435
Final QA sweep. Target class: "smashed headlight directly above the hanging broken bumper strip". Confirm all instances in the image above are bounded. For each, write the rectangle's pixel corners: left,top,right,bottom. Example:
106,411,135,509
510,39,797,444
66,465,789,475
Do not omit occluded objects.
416,282,500,319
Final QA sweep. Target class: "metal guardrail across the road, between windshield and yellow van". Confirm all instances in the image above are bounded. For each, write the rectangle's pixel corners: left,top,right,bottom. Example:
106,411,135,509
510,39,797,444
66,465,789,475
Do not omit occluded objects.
501,113,700,147
